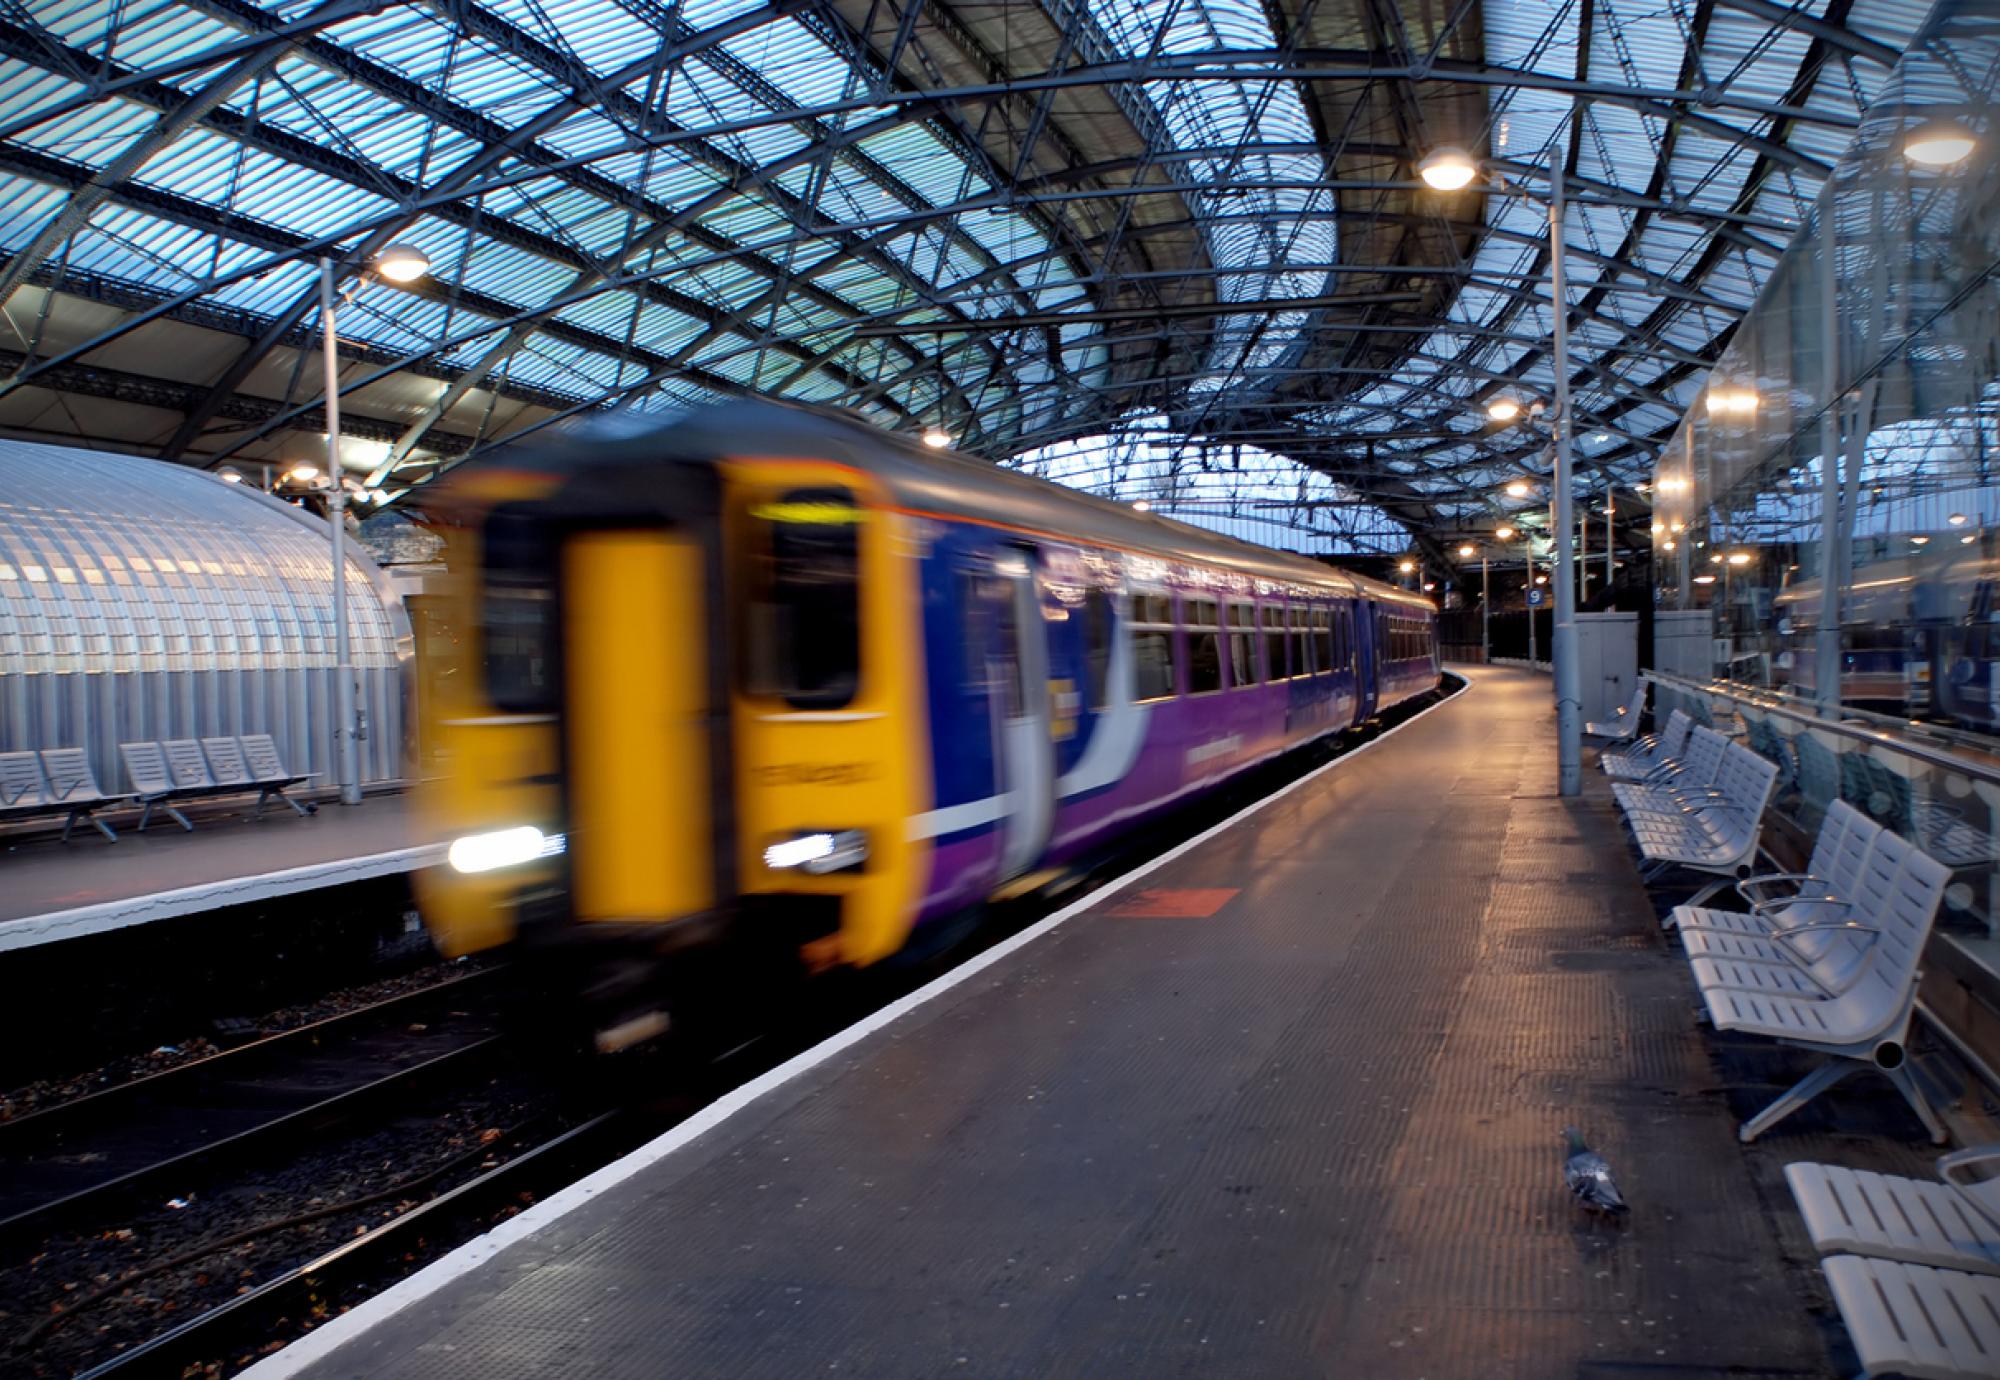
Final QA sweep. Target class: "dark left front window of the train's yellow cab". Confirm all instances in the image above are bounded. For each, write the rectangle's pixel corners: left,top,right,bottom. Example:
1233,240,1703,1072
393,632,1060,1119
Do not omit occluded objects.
480,508,558,714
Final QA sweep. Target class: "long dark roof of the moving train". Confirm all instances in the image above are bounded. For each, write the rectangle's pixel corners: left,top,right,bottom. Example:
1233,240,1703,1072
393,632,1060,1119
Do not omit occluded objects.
492,400,1436,610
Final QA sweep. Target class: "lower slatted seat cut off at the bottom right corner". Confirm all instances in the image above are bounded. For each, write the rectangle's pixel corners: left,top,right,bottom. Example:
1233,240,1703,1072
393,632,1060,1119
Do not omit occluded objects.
1820,1256,2000,1380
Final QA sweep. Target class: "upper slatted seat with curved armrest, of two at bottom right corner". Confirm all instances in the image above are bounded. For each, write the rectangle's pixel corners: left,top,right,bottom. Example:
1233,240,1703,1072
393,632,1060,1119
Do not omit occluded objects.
1784,1144,2000,1274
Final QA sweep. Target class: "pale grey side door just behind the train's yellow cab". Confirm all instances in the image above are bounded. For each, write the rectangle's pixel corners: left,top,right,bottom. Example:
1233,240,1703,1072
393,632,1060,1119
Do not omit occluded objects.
992,548,1056,882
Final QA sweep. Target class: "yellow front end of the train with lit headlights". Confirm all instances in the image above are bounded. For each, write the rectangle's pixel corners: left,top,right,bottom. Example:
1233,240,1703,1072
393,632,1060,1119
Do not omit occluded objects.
422,448,922,1032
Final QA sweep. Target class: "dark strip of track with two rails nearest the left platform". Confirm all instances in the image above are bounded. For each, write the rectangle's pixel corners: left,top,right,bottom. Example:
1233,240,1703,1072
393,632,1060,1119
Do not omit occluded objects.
0,968,500,1250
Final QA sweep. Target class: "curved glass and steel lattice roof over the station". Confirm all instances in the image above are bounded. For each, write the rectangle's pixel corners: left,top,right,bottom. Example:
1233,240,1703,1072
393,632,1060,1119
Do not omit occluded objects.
0,0,1928,560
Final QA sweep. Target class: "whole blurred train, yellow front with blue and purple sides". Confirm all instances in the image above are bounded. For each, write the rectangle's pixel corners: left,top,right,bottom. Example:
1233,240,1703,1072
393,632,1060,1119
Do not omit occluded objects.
420,404,1438,1020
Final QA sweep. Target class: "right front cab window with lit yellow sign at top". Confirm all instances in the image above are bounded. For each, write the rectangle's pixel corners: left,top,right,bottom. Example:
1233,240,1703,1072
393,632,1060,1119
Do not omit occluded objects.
744,488,862,710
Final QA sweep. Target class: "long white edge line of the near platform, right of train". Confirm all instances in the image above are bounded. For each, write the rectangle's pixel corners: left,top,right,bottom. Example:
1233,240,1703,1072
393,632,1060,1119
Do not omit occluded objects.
238,672,1478,1380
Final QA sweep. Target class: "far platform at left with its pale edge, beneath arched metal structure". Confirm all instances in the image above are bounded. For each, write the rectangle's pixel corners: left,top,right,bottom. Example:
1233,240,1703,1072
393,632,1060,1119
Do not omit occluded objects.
0,794,444,952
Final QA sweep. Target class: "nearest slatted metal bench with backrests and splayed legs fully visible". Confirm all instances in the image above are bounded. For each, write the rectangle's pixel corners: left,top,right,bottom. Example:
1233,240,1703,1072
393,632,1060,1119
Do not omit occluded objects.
1690,830,1952,1144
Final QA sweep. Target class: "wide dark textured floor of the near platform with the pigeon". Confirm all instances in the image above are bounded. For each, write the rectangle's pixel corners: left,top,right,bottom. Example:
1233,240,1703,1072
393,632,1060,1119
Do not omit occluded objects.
282,668,1888,1380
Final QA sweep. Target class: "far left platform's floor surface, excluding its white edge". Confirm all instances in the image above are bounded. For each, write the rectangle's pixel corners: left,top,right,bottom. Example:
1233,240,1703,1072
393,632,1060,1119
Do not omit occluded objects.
0,794,424,924
